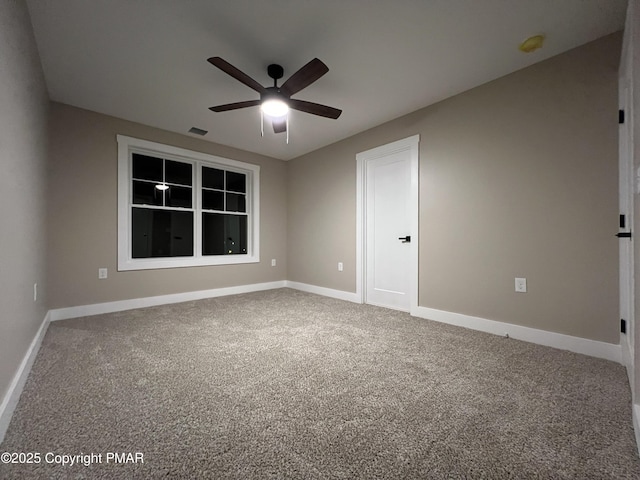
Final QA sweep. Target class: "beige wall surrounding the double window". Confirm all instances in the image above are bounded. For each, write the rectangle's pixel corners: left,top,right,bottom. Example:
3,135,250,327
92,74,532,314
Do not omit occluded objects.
47,103,287,308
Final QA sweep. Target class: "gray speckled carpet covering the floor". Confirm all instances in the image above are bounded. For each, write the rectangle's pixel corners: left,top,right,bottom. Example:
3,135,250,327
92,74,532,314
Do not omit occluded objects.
0,289,640,479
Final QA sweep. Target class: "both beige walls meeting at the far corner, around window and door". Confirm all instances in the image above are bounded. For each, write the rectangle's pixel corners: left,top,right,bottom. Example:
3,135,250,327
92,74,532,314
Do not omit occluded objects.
40,31,620,343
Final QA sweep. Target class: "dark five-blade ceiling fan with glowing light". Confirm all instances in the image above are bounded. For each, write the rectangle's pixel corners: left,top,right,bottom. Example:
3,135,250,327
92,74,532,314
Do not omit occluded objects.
207,57,342,133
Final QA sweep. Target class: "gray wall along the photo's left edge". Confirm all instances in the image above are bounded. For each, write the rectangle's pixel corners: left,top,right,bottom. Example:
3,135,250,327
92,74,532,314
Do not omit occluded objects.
0,0,48,401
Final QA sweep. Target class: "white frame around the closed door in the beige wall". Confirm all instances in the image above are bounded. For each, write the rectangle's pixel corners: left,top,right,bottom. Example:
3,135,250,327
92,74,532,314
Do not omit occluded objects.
356,135,420,314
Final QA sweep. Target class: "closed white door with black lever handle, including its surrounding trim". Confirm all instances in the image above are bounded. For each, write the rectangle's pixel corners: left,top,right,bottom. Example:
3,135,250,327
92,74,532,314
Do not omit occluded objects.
358,137,418,311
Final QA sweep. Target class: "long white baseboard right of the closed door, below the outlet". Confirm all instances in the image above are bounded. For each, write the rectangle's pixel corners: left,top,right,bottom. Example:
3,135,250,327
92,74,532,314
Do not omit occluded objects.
411,307,622,363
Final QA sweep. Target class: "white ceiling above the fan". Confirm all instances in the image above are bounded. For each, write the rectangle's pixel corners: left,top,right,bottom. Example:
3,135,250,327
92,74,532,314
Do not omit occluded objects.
27,0,627,160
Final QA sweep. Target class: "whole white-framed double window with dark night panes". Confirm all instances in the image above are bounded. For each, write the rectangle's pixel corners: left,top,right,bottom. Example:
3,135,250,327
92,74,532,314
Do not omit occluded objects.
118,135,260,270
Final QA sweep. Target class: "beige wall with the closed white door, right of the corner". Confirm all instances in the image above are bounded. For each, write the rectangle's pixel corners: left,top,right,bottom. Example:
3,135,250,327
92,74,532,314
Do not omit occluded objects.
288,34,621,343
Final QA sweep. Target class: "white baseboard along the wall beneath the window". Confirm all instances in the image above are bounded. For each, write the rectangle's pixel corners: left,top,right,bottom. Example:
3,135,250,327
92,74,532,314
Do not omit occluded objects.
49,280,286,322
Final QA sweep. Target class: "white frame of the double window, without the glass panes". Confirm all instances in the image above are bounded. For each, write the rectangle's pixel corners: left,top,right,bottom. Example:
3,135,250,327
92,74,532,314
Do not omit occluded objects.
117,135,260,271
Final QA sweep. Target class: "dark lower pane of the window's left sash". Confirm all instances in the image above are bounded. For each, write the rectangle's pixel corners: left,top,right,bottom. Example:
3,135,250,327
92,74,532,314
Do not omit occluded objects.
131,208,193,258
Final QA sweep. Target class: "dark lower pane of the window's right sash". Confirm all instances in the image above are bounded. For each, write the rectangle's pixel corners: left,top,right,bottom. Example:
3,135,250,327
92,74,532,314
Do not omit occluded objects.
202,213,247,255
